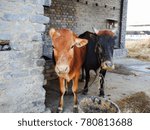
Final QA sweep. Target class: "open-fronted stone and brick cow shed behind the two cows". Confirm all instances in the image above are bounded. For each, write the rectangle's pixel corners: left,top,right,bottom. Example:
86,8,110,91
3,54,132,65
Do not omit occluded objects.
0,0,127,112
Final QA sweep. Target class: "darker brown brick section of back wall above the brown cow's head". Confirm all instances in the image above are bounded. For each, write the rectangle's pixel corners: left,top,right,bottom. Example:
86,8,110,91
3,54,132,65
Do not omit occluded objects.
45,0,76,30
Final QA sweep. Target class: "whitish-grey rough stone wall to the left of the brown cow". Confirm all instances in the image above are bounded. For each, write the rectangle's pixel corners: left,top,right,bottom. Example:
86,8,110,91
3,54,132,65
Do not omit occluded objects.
0,0,51,112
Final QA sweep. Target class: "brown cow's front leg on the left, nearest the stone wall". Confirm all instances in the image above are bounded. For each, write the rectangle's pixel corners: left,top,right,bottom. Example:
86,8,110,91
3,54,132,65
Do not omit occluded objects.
57,78,65,113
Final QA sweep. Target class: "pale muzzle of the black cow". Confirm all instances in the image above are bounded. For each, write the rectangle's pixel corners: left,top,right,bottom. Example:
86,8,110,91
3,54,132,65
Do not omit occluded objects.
101,61,115,70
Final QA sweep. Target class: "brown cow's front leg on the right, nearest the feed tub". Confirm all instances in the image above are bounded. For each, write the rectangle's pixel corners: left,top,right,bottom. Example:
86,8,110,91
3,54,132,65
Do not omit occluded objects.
72,75,79,113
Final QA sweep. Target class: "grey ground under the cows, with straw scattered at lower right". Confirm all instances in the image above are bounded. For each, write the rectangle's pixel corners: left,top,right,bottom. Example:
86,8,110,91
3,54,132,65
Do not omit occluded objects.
45,58,150,113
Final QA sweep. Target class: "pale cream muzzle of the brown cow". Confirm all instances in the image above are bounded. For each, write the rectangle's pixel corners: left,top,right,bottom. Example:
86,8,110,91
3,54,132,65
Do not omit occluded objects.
55,65,70,76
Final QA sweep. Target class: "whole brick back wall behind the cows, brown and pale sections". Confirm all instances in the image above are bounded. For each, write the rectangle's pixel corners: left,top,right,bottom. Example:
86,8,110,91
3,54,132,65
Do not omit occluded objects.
44,0,121,34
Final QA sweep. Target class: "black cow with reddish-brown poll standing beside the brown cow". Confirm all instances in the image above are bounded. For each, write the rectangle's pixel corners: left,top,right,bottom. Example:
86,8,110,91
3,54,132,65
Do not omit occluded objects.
79,30,116,97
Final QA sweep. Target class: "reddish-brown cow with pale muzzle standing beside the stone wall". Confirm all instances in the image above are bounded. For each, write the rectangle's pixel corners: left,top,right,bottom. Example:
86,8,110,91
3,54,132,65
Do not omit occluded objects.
49,28,88,112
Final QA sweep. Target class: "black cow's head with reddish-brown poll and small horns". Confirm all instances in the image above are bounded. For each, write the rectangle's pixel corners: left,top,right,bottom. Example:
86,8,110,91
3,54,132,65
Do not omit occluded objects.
95,30,116,70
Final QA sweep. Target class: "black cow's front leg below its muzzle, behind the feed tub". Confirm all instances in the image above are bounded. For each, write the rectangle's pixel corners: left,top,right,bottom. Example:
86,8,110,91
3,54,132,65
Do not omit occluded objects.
99,69,106,97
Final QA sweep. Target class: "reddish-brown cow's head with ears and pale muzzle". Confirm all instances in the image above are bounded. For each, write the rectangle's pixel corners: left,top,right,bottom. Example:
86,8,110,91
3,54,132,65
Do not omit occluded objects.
49,28,88,76
